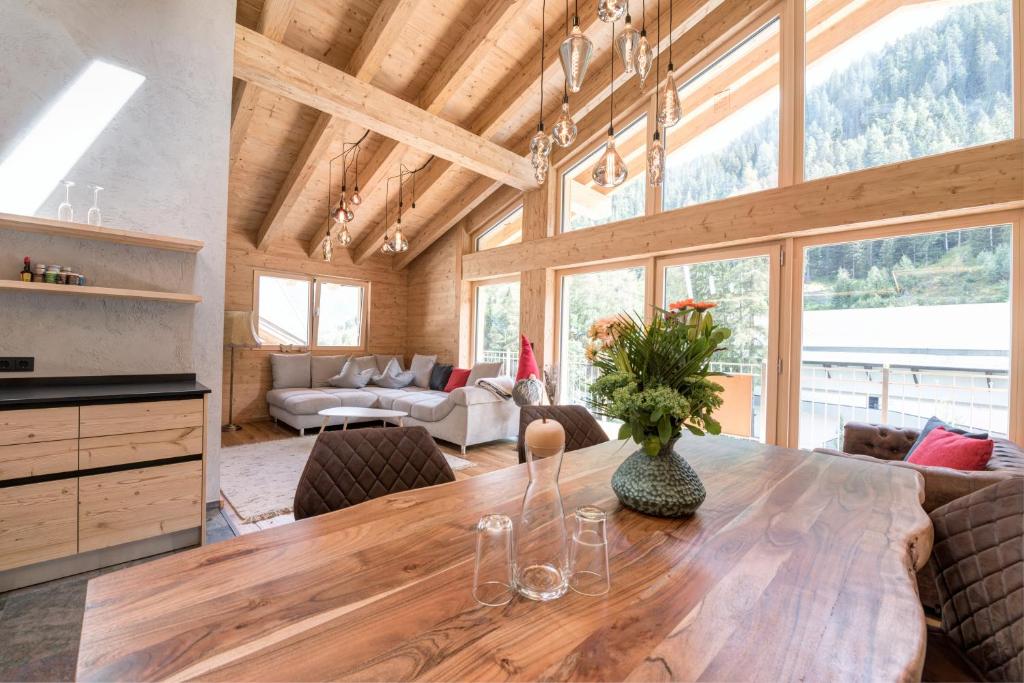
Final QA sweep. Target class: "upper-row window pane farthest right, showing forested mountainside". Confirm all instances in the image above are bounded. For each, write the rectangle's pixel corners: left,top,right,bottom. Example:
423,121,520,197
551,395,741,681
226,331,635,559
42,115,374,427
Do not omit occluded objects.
805,0,1020,178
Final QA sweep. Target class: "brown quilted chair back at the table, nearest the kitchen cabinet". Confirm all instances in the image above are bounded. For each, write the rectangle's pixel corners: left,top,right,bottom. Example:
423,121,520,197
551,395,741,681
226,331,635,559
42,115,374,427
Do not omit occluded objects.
294,427,455,519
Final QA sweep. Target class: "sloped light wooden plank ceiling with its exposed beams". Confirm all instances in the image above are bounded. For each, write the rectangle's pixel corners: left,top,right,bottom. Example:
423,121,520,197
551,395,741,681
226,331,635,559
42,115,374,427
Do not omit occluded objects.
228,0,729,268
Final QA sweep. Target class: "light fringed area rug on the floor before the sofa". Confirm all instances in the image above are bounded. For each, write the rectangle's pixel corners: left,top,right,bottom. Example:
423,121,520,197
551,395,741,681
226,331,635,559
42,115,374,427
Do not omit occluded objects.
220,436,473,524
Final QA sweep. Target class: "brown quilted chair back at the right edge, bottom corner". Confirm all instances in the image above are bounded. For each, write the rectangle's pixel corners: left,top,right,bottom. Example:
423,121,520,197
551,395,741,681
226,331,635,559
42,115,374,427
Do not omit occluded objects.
930,477,1024,681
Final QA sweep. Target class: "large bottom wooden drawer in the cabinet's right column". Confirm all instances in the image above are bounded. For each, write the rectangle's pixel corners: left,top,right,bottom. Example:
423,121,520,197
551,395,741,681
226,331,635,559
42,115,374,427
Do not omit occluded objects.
78,461,203,553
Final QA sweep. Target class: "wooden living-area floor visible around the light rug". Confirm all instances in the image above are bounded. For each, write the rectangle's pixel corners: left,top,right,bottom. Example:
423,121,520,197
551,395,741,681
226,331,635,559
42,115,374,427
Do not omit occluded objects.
220,420,519,535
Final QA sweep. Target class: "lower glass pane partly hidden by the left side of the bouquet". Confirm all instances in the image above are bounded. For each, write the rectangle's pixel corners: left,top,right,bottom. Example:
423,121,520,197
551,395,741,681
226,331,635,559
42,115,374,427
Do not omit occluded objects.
558,266,647,404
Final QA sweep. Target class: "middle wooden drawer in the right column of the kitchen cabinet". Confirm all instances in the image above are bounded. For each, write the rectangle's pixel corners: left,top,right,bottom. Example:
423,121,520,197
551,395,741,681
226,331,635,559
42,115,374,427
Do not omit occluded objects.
78,426,203,470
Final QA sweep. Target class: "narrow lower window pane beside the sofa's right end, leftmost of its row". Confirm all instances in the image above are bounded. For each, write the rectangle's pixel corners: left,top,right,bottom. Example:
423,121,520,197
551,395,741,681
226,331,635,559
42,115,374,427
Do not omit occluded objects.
473,280,519,376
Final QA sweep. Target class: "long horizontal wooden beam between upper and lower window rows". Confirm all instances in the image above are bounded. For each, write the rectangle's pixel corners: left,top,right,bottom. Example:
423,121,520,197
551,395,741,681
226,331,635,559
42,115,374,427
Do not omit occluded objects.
464,140,1024,280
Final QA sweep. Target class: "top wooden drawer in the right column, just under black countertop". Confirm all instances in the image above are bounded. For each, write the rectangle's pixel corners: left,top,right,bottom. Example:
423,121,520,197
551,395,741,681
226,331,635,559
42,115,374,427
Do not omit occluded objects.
81,398,203,438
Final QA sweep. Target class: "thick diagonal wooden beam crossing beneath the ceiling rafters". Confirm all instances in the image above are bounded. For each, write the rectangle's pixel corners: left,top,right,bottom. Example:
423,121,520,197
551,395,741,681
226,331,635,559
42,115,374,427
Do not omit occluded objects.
234,26,537,189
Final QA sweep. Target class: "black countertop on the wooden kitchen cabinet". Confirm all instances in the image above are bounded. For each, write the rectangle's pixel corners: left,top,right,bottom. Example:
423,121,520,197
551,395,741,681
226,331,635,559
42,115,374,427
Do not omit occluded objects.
0,375,210,411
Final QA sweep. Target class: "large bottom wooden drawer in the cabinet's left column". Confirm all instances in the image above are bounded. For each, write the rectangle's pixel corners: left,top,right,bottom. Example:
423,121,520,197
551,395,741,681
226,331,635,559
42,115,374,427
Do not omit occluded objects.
0,479,78,570
